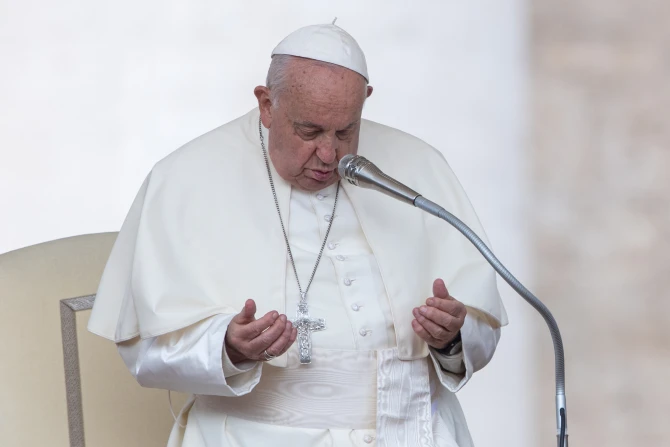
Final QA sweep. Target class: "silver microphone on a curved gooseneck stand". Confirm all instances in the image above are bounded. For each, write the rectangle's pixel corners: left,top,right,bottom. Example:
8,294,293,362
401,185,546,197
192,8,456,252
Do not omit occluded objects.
337,154,568,447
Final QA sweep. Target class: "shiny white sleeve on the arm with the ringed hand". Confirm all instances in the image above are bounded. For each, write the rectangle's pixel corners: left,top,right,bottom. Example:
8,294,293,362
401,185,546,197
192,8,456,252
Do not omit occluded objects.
117,314,262,396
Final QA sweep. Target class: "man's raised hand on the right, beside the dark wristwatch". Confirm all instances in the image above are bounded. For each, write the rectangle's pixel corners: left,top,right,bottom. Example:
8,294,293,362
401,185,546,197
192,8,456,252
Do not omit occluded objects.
412,279,467,349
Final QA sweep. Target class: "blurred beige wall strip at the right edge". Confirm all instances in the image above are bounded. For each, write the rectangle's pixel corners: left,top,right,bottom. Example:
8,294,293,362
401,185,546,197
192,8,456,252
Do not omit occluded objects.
529,0,670,447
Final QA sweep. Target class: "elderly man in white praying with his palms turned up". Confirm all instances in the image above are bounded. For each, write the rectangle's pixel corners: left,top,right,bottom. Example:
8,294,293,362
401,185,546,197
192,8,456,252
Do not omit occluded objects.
89,25,506,447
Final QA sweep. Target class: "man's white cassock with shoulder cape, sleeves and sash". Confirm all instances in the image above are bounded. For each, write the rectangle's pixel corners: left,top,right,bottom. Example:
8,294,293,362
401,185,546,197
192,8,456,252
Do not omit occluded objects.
89,110,506,447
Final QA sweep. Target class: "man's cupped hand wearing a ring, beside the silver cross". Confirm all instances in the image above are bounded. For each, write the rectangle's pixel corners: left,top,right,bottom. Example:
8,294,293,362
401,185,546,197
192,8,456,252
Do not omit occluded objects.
226,300,298,363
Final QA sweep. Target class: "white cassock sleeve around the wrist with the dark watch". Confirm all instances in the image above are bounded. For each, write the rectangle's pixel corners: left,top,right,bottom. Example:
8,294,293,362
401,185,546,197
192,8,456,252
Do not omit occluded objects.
430,307,500,393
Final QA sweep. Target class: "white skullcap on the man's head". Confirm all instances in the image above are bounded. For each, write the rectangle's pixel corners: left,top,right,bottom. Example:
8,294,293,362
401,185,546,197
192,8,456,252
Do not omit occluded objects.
272,25,370,82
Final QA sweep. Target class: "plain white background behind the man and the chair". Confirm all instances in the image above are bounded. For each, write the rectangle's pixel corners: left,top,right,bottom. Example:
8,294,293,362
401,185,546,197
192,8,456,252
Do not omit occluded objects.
0,0,536,447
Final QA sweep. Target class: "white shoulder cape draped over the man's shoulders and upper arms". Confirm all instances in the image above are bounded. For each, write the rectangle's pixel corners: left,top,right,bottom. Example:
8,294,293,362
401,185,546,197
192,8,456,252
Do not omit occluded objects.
88,109,507,366
